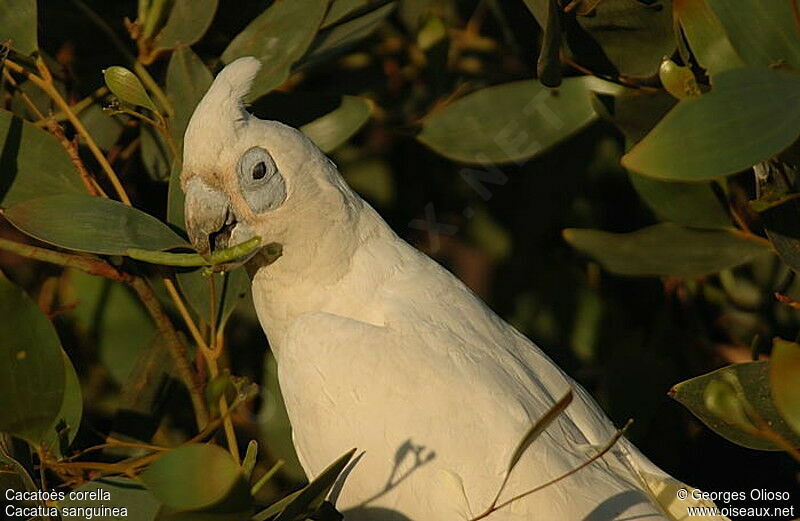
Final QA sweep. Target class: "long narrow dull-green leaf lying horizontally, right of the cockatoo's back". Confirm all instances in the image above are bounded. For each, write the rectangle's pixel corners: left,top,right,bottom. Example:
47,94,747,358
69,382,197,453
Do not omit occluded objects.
564,223,770,278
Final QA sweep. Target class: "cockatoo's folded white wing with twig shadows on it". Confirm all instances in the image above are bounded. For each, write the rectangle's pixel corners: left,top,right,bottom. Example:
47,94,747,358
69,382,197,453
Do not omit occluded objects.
279,306,665,521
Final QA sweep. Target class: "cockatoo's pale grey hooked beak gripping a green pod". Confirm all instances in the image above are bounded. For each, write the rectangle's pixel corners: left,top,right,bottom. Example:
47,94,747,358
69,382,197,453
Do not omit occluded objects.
184,177,231,255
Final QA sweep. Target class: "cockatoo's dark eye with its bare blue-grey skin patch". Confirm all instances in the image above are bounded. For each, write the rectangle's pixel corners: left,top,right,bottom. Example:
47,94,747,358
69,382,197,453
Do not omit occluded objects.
237,147,286,213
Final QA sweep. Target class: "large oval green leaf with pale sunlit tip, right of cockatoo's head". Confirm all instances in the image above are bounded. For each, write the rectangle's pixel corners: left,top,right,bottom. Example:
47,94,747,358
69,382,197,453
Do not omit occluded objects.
417,77,621,164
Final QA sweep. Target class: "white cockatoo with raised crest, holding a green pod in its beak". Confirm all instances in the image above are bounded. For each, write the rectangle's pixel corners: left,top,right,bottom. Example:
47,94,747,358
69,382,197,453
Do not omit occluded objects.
181,58,721,521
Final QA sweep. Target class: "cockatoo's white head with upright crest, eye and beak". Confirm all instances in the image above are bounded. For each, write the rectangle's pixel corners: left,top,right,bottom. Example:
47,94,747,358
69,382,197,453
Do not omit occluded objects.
181,57,352,266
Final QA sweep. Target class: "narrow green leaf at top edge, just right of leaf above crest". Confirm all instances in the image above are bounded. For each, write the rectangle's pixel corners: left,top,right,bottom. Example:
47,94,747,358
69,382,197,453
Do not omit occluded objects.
298,0,397,68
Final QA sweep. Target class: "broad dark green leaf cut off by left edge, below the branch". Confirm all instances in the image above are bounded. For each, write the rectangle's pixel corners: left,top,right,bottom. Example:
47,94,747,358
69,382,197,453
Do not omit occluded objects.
0,272,66,446
